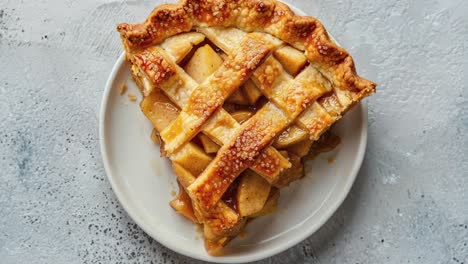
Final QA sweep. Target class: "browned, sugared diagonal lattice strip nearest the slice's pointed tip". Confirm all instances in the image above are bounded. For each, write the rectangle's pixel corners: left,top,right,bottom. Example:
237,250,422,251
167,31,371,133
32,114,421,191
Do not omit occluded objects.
188,103,291,210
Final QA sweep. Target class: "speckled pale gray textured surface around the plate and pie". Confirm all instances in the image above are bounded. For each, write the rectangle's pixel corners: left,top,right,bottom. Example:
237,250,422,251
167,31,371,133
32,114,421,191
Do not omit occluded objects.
0,0,468,263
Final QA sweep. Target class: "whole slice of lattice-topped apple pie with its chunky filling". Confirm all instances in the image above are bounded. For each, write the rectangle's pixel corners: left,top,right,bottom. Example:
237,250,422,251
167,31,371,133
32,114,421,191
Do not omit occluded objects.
117,0,376,255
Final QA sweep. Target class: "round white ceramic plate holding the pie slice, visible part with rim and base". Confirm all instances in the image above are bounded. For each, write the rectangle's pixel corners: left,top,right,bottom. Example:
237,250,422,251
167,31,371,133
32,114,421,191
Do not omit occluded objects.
99,3,367,263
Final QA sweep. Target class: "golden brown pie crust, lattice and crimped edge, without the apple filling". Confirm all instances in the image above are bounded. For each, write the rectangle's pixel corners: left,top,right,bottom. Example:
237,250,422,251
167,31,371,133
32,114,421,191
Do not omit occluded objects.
117,0,376,254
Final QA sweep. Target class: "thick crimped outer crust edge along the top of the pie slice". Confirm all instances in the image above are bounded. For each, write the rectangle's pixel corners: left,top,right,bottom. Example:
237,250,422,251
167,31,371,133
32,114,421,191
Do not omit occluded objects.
117,0,376,94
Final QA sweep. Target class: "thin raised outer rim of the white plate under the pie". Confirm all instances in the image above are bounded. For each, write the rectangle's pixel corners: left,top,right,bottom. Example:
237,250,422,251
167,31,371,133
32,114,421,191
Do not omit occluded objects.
99,4,368,263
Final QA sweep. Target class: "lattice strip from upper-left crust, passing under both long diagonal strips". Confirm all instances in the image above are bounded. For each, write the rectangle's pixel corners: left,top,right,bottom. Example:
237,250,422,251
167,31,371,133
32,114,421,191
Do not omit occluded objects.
128,37,291,182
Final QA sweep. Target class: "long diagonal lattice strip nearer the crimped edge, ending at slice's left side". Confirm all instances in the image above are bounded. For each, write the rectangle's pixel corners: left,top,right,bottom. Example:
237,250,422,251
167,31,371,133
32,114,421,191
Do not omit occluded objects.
157,33,281,153
